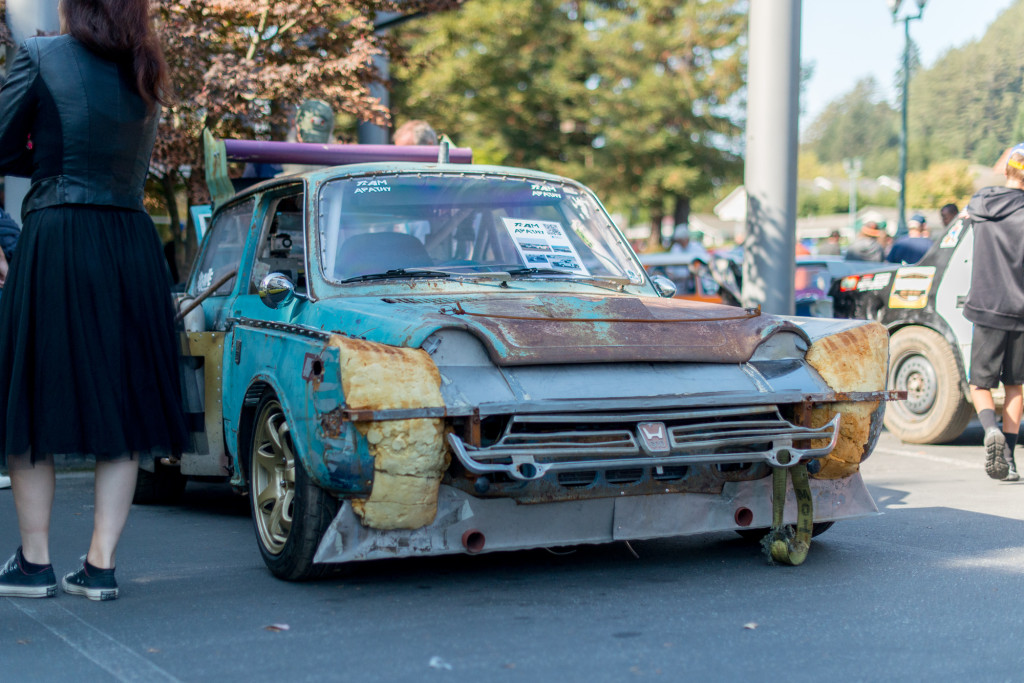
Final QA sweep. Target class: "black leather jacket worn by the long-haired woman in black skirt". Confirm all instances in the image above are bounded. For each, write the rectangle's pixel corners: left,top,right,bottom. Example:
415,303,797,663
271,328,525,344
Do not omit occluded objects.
0,35,159,216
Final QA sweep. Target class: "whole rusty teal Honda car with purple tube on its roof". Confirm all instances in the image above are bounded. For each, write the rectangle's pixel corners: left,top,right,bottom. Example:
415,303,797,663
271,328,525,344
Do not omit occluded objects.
159,138,891,580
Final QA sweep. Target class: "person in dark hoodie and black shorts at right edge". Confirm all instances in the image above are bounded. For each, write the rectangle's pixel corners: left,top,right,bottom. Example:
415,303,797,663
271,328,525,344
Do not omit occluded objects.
964,143,1024,481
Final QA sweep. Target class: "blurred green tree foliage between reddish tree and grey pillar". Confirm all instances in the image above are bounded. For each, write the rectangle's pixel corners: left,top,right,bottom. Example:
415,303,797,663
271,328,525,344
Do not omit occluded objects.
394,0,746,237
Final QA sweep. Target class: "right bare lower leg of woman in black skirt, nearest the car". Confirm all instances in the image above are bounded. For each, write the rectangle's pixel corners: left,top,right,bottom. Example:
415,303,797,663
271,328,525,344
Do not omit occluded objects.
86,458,138,569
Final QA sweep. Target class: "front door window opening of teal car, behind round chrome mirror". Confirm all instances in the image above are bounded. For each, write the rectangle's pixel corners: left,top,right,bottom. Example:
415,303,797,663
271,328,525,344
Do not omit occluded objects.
249,193,306,294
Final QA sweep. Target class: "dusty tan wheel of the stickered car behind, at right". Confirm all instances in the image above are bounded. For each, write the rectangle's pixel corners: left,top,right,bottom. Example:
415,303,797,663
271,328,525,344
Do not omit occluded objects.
885,326,974,443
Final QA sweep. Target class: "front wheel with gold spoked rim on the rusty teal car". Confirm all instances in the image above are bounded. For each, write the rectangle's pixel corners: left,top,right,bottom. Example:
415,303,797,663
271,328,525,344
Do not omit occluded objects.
246,393,338,581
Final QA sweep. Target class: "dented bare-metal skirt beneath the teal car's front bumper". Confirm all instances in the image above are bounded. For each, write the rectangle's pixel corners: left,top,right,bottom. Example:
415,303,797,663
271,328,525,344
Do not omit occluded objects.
313,473,878,563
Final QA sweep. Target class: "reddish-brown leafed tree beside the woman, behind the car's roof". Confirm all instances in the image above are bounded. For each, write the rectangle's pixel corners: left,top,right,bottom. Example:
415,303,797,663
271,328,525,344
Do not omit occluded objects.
152,0,462,262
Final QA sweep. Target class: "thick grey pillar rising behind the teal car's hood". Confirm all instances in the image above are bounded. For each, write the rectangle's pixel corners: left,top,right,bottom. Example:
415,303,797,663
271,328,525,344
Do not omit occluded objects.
742,0,801,315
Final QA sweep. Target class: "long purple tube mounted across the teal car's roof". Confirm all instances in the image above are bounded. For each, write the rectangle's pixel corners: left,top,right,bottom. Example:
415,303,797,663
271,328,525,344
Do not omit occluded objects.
224,140,473,166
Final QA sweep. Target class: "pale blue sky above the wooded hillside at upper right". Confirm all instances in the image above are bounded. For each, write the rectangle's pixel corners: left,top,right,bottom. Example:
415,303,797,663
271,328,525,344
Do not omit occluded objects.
806,0,1014,130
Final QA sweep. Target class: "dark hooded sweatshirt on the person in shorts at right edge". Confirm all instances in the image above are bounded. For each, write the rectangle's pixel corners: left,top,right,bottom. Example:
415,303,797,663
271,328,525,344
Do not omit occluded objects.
964,187,1024,330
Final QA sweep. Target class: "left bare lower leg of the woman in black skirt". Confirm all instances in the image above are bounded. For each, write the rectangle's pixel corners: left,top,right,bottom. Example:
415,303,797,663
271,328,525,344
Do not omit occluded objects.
7,454,56,564
